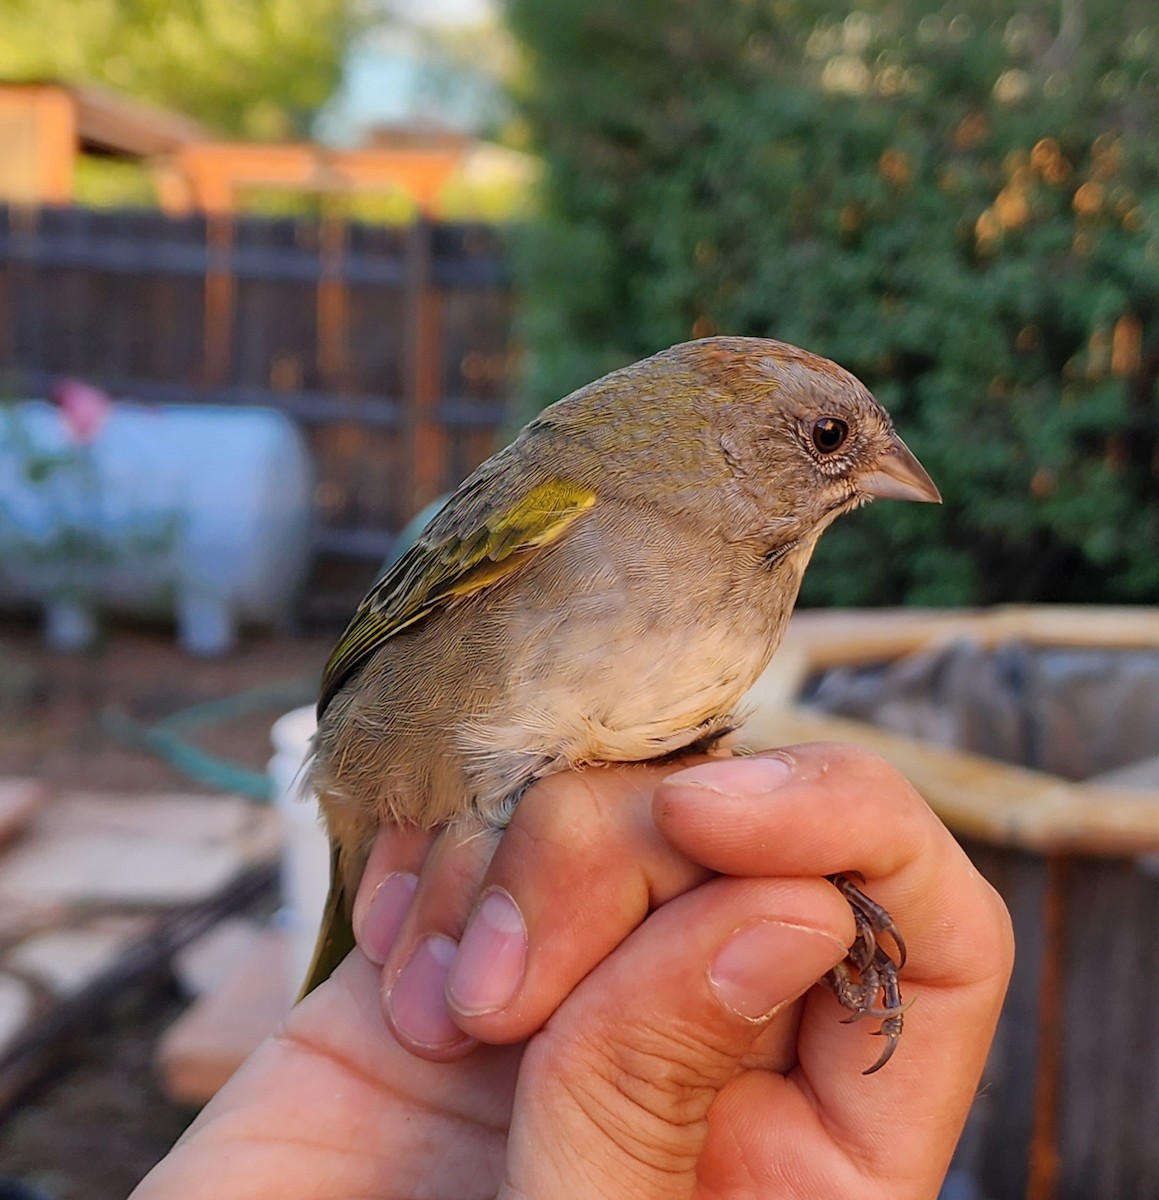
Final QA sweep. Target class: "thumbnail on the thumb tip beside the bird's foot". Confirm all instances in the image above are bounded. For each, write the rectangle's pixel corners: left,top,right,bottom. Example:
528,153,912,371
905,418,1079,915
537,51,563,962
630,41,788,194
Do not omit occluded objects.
708,920,846,1021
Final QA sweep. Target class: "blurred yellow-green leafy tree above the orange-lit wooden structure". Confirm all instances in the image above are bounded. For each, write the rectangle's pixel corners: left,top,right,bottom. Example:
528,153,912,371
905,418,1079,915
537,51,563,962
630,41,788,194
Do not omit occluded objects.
0,0,366,138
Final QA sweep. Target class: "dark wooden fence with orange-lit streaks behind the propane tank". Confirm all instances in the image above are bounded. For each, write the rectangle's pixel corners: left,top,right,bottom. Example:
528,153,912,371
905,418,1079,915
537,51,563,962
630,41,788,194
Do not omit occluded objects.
0,208,511,559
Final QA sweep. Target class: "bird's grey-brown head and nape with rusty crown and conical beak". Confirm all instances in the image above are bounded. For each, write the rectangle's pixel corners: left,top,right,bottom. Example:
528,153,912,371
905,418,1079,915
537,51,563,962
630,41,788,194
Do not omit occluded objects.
535,337,941,559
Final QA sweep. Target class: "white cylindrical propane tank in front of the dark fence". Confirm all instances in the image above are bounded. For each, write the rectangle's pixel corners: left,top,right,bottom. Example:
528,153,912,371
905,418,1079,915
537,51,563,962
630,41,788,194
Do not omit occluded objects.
0,401,313,654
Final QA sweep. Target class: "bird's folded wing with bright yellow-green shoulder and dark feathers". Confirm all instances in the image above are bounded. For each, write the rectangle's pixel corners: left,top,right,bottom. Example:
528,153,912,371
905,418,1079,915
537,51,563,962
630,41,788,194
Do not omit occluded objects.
318,469,595,716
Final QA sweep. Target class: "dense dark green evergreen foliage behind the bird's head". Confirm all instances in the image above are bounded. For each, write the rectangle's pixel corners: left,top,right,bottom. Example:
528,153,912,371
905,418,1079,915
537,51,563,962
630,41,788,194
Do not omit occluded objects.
509,0,1159,604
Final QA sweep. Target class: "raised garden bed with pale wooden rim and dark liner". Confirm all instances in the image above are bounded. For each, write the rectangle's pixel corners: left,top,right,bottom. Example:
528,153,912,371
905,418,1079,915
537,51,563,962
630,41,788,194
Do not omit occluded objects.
745,608,1159,1200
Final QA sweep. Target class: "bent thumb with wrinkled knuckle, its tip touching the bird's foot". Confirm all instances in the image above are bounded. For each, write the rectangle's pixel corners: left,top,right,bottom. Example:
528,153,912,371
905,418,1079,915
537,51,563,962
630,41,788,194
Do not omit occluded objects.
499,878,853,1200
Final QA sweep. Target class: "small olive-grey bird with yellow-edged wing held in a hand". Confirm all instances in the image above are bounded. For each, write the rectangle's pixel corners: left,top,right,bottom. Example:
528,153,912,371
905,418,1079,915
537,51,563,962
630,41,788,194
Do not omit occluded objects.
304,337,941,1069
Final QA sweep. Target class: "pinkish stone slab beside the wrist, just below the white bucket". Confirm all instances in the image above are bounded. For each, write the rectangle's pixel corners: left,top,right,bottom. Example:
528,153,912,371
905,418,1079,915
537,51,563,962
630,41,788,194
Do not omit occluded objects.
157,929,292,1104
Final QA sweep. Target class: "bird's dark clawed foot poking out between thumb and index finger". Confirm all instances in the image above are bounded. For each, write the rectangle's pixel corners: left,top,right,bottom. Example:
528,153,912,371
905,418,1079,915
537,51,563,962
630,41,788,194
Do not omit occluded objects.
824,875,907,1075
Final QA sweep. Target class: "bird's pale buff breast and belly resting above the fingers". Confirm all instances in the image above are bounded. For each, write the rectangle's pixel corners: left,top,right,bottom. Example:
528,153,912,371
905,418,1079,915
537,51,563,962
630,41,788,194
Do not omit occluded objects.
458,508,793,806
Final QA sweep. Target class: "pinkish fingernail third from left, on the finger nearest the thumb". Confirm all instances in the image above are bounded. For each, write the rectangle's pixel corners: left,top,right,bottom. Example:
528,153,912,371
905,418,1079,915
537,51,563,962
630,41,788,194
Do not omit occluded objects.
446,888,527,1016
